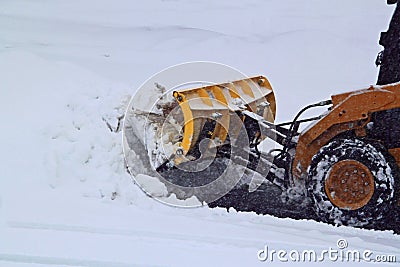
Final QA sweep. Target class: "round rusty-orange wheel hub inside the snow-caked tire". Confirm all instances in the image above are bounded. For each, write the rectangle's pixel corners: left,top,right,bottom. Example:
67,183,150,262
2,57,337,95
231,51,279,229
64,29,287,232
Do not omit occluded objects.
325,160,375,210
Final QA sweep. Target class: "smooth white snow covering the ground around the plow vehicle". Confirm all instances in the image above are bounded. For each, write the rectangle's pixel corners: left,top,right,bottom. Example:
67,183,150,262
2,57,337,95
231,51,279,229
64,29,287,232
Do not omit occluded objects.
0,0,400,266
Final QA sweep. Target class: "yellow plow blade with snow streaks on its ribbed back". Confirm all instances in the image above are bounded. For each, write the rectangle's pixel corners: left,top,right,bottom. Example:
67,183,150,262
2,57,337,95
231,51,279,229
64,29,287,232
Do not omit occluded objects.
173,76,276,159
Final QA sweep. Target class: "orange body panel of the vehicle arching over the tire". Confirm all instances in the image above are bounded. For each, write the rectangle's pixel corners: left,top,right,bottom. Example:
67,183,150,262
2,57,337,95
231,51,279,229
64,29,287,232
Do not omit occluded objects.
292,83,400,181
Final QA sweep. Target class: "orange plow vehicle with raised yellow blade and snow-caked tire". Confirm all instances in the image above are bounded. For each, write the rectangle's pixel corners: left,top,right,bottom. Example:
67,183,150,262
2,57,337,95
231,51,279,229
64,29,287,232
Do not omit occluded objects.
123,76,400,228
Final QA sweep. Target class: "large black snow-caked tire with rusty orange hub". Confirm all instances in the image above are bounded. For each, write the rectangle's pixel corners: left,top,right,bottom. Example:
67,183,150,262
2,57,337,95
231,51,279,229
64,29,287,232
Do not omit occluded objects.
307,139,397,226
